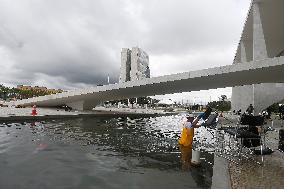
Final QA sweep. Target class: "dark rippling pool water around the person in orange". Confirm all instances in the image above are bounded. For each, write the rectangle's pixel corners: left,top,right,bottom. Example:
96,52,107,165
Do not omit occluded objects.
0,115,214,188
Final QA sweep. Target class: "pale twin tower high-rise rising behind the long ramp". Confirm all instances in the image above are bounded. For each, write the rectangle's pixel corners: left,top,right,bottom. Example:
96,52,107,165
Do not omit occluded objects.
119,47,150,83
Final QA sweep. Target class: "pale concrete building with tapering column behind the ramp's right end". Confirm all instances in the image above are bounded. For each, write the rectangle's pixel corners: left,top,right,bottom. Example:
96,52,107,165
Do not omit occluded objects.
232,0,284,113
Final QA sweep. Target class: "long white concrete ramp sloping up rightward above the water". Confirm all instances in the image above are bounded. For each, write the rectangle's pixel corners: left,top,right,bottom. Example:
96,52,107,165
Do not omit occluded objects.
7,57,284,110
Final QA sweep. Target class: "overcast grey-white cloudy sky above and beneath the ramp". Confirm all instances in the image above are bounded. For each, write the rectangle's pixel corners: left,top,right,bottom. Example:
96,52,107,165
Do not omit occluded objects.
0,0,250,101
